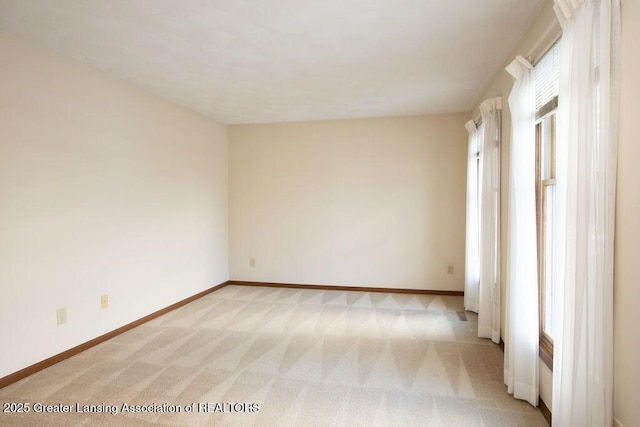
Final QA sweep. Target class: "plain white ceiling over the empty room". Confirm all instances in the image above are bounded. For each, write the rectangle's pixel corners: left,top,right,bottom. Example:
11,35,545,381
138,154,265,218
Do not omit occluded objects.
0,0,546,123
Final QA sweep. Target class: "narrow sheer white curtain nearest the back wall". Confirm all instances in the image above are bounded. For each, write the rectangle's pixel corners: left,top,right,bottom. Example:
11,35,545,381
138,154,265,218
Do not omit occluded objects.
464,120,480,313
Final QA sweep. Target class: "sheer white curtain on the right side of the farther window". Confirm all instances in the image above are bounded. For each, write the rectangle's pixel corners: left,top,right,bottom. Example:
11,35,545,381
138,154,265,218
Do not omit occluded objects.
478,98,502,343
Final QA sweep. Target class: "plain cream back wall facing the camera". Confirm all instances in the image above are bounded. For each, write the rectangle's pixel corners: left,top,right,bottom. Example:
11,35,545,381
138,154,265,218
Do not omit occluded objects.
229,114,468,291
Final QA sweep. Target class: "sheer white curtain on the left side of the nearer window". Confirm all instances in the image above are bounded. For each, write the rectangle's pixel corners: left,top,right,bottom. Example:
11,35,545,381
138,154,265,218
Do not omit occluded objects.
504,56,540,406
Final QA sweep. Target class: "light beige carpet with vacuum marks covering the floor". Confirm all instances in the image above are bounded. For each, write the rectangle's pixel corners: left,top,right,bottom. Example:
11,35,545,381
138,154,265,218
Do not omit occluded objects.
0,286,547,427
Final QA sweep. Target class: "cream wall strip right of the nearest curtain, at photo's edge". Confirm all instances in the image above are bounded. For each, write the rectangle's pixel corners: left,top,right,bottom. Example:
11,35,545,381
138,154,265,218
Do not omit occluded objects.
613,1,640,427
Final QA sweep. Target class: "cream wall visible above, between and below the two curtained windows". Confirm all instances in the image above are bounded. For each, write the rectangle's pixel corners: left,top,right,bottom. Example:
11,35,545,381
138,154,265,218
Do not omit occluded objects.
472,1,561,411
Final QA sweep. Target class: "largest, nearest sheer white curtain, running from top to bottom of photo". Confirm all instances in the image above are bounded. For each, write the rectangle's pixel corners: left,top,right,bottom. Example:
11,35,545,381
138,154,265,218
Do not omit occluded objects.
553,0,620,426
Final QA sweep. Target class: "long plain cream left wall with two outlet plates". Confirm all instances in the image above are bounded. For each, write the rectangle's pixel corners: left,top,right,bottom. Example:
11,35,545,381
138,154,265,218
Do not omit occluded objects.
0,33,228,377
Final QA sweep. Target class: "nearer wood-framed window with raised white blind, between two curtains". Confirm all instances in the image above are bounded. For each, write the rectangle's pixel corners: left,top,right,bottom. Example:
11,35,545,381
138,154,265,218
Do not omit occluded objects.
534,43,560,369
